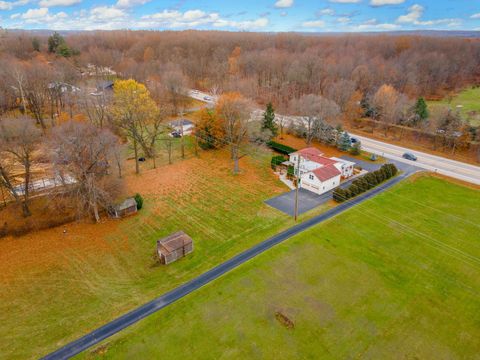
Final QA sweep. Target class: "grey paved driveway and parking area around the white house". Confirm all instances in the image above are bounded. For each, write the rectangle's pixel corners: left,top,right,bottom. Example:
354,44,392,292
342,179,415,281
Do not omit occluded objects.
265,155,420,216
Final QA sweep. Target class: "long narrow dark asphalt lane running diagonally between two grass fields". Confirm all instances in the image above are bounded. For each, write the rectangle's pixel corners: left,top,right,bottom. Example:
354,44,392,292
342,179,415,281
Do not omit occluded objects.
44,173,410,360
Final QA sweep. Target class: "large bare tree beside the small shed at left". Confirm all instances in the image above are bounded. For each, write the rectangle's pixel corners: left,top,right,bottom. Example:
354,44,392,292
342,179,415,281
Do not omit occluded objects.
51,121,122,222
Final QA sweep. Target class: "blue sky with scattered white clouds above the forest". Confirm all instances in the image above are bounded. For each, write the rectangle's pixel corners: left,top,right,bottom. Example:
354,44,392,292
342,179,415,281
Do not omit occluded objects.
0,0,480,32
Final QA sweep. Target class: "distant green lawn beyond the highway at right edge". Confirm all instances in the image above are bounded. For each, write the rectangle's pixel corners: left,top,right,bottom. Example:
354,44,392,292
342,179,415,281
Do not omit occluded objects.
428,88,480,126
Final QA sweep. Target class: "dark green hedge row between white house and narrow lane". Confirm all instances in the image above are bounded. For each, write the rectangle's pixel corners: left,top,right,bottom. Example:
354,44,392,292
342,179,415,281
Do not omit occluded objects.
333,164,398,203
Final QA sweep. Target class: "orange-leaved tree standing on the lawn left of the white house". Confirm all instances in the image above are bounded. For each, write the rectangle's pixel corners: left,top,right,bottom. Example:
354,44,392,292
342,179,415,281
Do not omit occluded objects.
216,92,252,174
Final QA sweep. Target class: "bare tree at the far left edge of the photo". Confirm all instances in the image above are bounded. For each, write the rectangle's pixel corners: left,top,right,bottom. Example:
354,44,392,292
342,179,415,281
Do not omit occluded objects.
0,118,41,217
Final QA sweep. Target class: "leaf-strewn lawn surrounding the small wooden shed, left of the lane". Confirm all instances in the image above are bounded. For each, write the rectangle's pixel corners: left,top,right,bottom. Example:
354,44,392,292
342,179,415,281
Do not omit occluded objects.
0,145,336,359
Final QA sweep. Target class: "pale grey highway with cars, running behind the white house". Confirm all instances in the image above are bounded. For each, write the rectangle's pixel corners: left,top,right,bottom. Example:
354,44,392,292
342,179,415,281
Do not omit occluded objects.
189,90,480,185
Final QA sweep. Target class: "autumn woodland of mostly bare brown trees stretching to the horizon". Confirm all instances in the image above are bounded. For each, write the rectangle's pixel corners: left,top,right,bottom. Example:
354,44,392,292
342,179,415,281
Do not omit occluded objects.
0,31,480,229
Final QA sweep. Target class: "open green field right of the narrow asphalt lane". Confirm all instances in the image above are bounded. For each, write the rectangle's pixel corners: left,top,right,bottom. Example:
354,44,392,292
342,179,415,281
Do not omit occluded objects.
79,176,480,359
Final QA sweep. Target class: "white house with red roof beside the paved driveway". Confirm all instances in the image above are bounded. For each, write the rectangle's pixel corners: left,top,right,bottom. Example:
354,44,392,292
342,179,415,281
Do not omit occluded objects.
290,147,355,195
